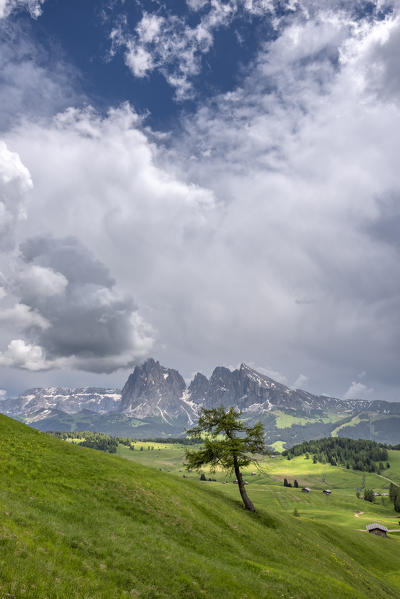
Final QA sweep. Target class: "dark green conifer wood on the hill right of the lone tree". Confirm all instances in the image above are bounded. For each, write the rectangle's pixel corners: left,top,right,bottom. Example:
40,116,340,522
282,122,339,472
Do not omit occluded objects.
284,437,388,472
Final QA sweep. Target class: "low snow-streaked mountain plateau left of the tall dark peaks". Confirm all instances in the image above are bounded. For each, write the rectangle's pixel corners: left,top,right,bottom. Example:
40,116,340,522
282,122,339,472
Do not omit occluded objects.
0,387,121,416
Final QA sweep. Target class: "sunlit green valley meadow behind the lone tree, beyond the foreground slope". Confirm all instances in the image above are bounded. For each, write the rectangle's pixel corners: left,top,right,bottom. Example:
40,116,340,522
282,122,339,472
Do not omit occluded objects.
118,442,400,541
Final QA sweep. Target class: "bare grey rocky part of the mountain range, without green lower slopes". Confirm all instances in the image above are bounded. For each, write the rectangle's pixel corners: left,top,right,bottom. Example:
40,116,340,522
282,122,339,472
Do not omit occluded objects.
0,359,400,432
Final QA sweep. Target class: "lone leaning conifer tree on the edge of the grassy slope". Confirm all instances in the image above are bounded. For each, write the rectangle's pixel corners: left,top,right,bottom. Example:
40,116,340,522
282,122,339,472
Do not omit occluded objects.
185,406,265,512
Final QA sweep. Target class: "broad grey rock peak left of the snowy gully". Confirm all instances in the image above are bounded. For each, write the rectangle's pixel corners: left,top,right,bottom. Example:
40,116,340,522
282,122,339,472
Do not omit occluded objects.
120,359,190,422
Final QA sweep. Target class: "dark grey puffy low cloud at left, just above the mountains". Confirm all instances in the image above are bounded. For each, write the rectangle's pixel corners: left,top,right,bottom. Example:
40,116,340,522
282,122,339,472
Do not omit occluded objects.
0,237,153,372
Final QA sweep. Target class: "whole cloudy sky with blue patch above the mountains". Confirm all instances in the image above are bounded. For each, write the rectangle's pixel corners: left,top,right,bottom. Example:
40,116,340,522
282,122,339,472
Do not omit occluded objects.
0,0,400,401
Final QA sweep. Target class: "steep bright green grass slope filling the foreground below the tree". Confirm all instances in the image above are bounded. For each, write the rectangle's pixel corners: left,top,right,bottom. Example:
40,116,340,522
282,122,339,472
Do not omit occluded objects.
0,416,400,599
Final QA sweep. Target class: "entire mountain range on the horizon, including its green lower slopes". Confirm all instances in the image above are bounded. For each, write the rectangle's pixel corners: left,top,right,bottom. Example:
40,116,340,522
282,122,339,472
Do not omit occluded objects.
0,358,400,449
